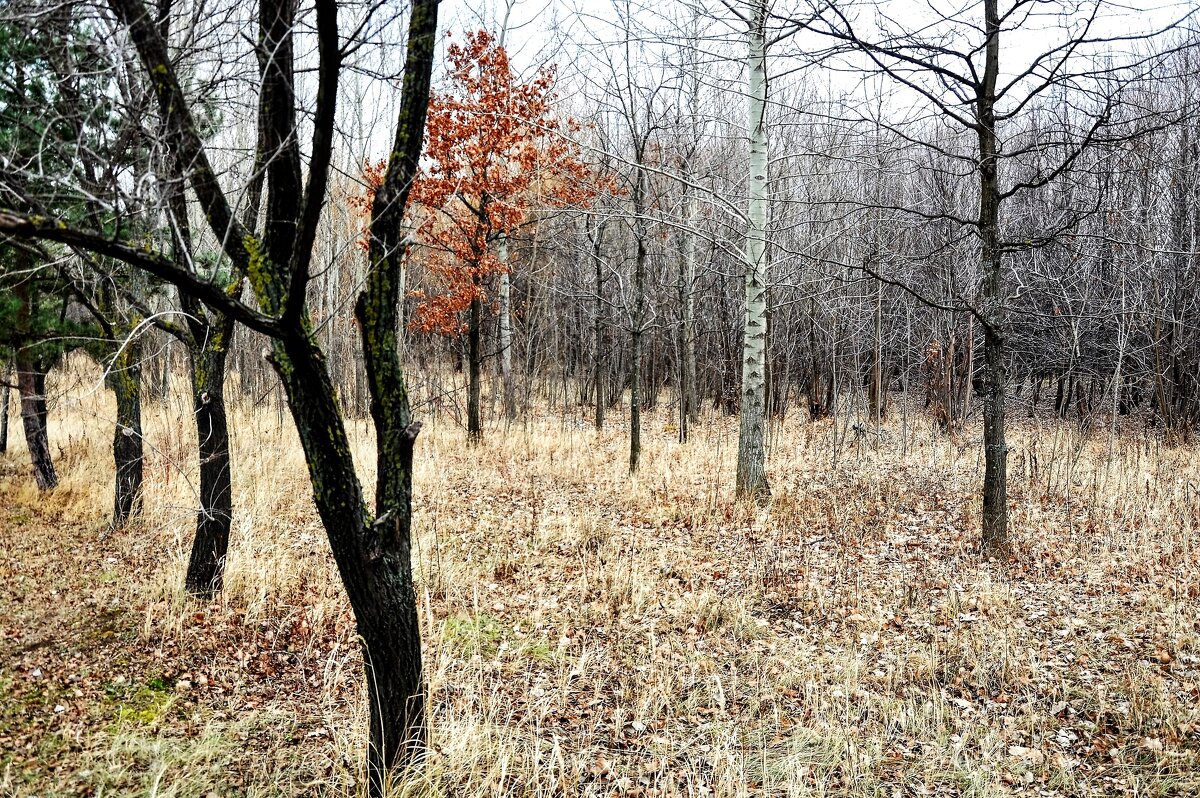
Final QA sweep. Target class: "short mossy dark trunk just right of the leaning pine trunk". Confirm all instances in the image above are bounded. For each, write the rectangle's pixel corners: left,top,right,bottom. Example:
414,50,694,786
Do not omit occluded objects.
107,340,143,529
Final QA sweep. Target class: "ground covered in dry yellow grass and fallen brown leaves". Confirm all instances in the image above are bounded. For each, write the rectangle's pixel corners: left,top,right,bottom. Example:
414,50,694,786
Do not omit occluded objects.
0,364,1200,798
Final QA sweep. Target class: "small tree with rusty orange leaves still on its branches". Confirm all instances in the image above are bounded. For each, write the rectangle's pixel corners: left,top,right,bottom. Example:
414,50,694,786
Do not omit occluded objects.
410,31,606,440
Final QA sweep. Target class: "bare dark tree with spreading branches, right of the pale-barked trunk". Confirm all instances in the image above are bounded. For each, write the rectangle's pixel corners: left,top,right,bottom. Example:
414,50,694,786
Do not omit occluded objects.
796,0,1190,552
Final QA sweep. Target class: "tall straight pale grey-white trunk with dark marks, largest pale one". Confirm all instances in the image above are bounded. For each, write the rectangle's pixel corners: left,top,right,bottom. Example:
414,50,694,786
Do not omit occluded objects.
737,0,770,499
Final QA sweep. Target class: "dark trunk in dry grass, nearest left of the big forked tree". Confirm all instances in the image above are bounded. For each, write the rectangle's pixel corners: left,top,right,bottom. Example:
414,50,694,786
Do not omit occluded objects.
185,318,236,599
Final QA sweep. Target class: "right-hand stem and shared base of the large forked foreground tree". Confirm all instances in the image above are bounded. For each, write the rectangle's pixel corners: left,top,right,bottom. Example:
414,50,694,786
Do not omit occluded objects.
350,0,438,782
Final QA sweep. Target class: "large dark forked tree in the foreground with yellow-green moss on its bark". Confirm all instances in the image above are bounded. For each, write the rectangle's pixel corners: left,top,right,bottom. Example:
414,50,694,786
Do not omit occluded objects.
7,0,438,782
